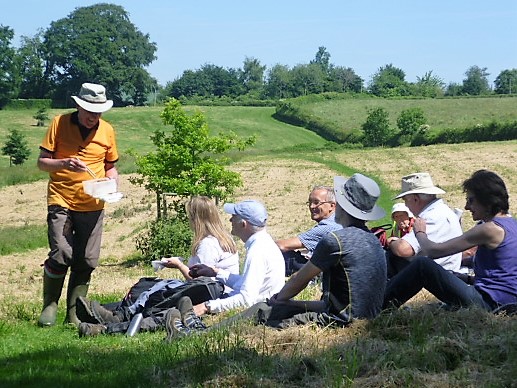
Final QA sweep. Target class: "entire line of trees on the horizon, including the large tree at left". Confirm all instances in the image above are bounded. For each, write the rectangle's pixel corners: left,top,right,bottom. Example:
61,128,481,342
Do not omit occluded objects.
0,3,517,108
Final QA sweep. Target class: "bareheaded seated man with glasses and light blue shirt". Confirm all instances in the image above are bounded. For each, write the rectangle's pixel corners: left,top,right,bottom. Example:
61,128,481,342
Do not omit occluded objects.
276,186,342,276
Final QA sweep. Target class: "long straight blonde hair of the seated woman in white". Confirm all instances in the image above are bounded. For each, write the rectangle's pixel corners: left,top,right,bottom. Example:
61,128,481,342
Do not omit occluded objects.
185,196,237,256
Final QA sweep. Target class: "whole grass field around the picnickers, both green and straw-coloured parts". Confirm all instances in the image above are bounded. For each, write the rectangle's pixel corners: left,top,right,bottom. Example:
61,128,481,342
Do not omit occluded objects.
0,101,517,387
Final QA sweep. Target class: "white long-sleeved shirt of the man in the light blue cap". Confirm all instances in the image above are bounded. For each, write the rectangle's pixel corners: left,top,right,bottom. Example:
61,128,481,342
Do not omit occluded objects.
207,230,285,313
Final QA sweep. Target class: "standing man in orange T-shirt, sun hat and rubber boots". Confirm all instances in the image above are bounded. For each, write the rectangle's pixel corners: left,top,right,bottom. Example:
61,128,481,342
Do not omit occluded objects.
38,83,118,326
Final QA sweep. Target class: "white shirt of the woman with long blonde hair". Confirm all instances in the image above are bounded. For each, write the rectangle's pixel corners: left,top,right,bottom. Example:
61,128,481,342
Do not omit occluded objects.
187,236,239,275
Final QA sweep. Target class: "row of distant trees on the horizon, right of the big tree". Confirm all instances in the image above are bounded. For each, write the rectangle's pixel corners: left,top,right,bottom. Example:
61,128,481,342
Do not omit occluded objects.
162,53,517,100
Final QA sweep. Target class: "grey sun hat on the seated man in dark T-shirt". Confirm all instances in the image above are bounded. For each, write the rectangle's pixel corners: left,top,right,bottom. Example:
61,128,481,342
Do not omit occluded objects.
334,174,386,221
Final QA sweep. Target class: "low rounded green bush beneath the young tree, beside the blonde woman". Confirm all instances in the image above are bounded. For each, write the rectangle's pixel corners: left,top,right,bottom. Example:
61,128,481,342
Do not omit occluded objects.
136,217,193,260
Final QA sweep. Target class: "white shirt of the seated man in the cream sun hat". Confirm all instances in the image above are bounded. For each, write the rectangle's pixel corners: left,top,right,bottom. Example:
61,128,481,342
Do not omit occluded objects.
402,199,463,272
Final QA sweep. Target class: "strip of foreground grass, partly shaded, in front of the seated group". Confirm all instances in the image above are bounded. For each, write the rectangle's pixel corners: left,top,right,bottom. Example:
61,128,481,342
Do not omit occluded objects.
0,302,517,387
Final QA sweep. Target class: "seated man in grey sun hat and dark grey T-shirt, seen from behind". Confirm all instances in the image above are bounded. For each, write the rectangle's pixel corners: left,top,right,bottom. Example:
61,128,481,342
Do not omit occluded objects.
166,174,386,340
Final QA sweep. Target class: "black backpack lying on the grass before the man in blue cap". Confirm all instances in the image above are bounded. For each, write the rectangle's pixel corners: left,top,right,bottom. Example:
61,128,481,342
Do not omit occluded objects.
121,277,224,317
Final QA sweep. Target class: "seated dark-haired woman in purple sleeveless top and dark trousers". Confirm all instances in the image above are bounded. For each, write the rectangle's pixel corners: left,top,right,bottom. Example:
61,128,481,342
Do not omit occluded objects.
384,170,517,311
